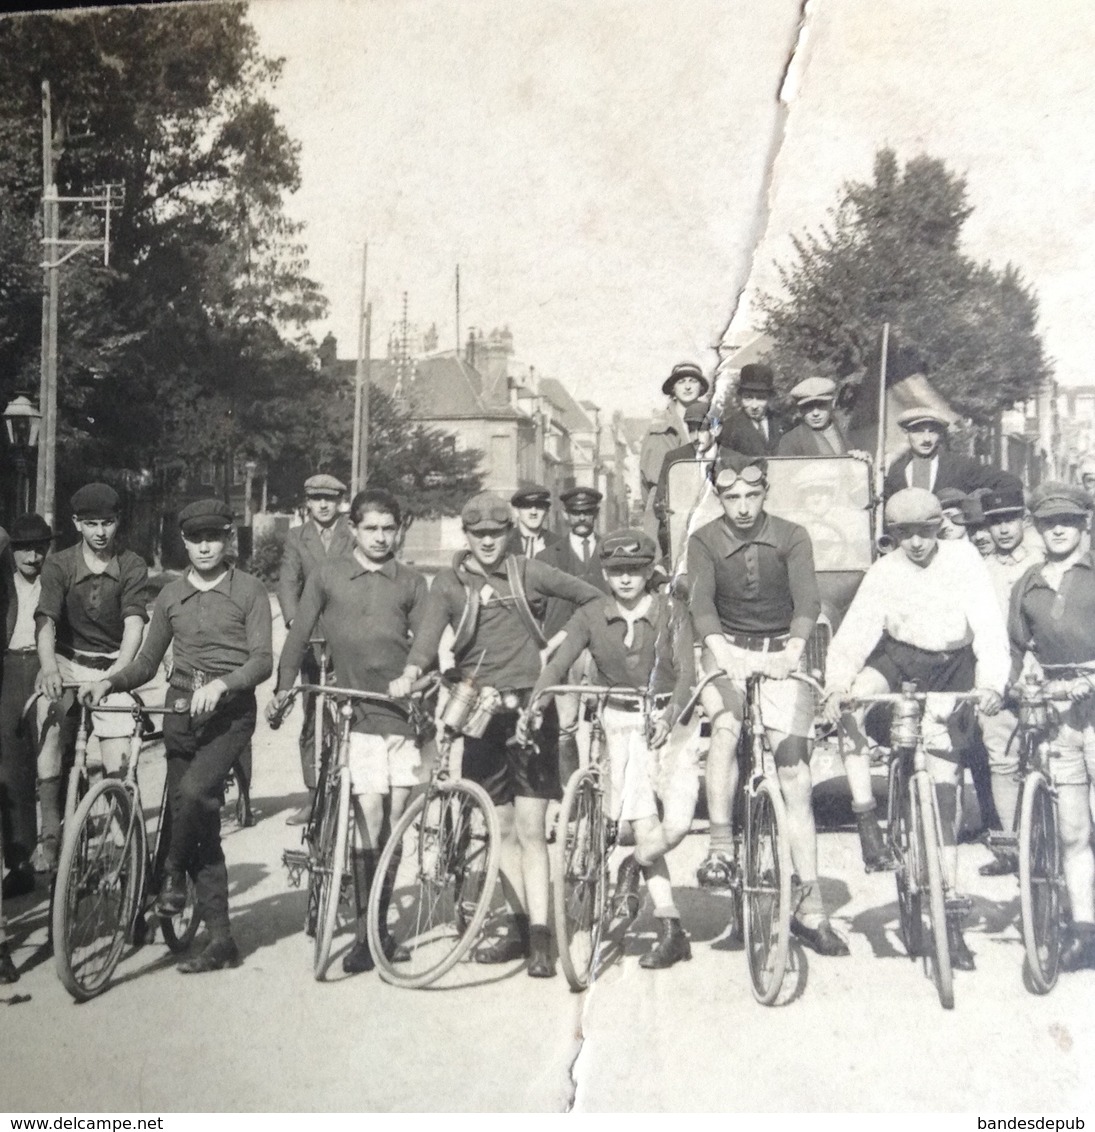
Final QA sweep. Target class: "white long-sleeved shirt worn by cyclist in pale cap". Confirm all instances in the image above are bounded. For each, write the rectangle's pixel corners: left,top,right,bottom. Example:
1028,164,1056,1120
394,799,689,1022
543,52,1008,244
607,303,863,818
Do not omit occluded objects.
825,541,1010,693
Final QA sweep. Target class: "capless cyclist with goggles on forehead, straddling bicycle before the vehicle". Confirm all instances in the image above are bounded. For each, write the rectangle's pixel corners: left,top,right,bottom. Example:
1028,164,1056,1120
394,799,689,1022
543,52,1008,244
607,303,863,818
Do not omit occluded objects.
688,452,848,955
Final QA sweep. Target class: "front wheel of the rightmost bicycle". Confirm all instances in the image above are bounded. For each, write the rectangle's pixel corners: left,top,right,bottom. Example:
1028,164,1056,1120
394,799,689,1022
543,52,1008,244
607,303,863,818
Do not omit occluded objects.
1019,771,1062,994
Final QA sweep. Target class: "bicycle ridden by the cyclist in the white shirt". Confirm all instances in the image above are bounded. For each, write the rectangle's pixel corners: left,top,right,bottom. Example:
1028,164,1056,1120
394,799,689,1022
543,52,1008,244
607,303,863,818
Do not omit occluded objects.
844,683,981,1010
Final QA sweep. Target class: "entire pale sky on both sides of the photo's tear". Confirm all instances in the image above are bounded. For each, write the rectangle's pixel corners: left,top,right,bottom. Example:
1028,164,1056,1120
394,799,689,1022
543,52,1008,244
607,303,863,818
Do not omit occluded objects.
245,0,1095,415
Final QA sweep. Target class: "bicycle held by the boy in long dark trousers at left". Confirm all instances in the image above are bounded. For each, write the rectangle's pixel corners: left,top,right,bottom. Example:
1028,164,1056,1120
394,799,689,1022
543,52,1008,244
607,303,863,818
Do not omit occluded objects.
51,704,199,1002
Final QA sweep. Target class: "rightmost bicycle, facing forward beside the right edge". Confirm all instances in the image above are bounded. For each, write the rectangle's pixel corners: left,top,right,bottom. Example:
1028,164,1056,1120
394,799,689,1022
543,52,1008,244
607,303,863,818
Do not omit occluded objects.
987,664,1078,994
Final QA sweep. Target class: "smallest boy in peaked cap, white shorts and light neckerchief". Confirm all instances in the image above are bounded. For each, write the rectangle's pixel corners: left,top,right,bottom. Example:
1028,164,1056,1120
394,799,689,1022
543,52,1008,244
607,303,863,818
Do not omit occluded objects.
517,530,700,969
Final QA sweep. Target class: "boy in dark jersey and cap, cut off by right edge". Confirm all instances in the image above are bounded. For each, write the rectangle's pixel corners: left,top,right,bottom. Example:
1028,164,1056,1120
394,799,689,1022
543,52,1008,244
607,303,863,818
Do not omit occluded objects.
1008,482,1095,971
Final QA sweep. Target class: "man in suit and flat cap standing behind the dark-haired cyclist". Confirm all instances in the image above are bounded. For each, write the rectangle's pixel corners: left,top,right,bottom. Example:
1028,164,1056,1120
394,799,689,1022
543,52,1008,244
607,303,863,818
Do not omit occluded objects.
277,473,354,825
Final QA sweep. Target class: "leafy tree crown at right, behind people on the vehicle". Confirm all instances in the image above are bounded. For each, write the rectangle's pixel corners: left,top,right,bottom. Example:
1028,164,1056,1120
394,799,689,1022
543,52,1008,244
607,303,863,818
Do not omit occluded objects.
762,149,1051,422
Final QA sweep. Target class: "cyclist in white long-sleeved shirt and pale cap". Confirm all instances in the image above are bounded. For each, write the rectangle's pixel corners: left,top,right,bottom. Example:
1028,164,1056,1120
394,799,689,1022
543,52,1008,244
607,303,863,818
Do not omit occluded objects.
824,488,1008,970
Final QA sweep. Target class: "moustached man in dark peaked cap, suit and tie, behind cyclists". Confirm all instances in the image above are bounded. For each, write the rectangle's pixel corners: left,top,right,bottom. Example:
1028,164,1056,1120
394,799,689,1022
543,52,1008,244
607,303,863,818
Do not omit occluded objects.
538,488,609,782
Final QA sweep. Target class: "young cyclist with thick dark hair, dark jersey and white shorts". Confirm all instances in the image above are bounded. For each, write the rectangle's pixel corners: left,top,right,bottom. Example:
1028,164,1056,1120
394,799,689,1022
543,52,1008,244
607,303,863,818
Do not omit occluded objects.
266,488,428,975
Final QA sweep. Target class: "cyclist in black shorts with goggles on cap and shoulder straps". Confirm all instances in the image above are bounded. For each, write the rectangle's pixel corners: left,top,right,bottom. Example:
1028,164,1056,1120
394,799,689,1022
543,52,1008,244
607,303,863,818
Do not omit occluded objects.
392,491,604,978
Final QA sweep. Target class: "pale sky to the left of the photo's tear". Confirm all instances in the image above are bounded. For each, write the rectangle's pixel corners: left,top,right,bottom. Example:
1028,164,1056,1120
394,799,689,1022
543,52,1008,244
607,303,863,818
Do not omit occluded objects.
245,0,799,414
